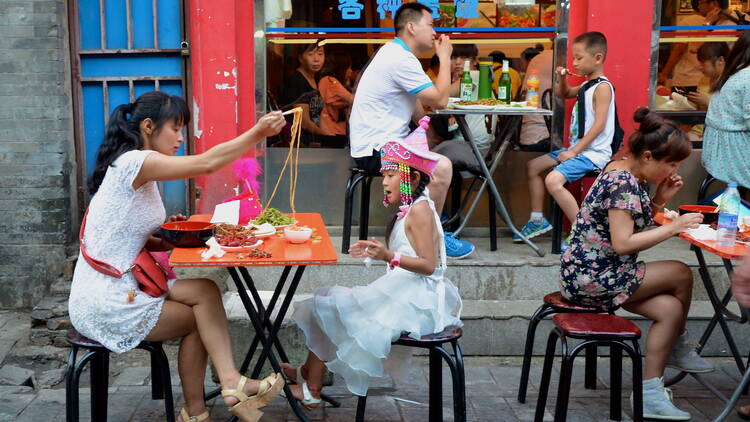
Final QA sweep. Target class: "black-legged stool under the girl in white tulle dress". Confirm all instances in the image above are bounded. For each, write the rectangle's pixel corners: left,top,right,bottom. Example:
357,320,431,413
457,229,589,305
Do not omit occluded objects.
355,327,466,422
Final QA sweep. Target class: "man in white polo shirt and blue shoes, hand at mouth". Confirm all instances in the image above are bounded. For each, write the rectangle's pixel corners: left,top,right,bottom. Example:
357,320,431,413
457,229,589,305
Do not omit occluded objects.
349,3,474,258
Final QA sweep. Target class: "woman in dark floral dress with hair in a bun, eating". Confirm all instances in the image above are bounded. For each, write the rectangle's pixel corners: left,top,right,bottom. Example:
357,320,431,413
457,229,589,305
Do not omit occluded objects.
560,108,713,420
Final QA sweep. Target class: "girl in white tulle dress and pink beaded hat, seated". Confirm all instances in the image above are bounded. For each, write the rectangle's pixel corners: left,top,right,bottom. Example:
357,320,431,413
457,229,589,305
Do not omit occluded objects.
284,119,462,408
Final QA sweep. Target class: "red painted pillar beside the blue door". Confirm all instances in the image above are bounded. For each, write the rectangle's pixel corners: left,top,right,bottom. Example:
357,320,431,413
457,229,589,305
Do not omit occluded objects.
188,0,255,213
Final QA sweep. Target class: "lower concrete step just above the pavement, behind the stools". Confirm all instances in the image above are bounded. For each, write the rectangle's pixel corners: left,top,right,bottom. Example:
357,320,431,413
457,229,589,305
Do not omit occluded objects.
224,291,750,363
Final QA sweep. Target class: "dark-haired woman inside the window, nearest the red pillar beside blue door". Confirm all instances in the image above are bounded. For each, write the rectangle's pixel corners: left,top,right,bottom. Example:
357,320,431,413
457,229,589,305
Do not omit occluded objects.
279,42,326,106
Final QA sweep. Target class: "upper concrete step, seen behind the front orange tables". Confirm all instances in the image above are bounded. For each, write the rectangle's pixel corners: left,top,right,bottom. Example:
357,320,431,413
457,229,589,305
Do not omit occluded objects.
178,237,729,301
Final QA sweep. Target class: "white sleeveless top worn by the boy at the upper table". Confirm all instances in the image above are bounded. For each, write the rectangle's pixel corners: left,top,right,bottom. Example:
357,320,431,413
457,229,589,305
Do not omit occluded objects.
569,76,615,169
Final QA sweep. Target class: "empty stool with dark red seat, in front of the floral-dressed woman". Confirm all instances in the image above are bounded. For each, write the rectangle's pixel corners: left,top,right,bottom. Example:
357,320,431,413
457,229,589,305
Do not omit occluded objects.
534,313,643,422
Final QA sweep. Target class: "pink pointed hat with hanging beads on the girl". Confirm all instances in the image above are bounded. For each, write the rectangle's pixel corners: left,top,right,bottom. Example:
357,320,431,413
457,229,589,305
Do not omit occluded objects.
380,116,438,205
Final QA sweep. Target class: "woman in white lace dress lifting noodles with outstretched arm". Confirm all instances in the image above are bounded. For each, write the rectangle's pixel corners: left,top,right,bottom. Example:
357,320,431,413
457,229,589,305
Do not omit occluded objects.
69,92,285,422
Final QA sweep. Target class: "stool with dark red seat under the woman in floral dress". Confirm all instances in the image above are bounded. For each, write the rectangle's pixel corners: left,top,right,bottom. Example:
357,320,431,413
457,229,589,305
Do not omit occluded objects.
518,292,605,403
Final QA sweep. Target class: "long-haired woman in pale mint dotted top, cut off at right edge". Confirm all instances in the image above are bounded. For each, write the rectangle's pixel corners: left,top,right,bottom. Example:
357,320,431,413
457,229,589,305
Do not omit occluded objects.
701,31,750,188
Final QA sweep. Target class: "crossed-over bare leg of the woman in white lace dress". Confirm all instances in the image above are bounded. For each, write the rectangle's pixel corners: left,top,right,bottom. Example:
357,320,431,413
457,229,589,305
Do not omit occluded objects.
147,279,274,406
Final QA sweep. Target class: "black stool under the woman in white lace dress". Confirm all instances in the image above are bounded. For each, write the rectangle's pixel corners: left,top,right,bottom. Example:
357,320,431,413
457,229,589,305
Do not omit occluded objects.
65,328,175,422
